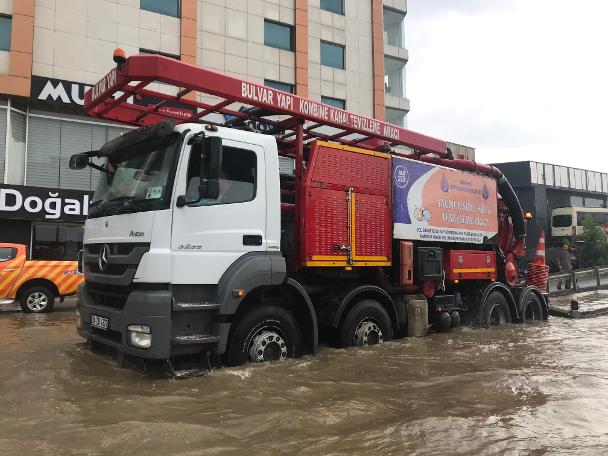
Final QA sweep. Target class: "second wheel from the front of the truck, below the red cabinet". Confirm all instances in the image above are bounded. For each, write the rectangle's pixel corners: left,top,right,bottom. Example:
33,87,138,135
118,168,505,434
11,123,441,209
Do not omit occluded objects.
338,299,393,347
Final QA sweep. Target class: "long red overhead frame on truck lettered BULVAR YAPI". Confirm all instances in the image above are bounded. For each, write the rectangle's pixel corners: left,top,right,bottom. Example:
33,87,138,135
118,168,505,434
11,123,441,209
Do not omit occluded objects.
84,54,448,157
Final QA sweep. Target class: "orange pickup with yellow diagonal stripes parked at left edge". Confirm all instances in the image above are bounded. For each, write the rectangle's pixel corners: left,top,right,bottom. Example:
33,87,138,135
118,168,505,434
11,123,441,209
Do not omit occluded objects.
0,243,84,312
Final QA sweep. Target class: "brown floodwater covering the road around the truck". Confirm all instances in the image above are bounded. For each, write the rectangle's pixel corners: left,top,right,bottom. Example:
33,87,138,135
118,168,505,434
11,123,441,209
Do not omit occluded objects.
0,298,608,456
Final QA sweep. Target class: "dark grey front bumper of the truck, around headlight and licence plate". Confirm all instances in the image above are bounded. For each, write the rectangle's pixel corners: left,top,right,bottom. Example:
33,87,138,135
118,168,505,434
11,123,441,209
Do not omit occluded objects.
78,283,172,359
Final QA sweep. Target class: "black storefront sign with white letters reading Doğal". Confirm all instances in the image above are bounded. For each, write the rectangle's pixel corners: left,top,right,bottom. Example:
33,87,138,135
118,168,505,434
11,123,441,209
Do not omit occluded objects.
0,185,92,221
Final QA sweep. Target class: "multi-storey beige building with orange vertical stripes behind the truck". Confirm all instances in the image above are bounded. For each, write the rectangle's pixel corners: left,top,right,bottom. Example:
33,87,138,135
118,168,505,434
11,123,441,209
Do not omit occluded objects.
0,0,409,259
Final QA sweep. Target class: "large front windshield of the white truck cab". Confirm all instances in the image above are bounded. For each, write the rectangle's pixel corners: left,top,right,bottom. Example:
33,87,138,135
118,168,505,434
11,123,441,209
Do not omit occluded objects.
89,133,180,218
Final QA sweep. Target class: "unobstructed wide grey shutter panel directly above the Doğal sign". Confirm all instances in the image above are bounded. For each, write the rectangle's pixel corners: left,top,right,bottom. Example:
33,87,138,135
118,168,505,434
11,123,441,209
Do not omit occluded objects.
26,117,61,188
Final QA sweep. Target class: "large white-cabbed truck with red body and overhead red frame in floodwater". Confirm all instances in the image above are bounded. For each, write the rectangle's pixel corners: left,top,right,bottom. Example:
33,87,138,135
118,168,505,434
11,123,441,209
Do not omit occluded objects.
70,51,548,365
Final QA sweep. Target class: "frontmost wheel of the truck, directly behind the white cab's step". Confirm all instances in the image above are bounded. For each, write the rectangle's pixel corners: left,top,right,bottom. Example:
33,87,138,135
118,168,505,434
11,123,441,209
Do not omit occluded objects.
224,306,303,366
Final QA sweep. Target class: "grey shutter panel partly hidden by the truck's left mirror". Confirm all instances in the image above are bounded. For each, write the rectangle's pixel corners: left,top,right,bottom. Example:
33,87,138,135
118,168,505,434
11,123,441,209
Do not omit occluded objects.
59,121,92,191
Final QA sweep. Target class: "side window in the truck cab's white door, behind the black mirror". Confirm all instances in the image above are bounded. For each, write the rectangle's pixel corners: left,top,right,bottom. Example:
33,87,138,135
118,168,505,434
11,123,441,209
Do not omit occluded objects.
186,146,257,206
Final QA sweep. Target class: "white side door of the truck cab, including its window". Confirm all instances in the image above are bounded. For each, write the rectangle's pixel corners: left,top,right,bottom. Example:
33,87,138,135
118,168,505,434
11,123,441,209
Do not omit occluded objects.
171,139,267,284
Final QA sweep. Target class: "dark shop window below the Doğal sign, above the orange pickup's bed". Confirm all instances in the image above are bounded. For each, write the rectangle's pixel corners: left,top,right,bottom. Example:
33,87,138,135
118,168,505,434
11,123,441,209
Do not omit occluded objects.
32,223,84,261
